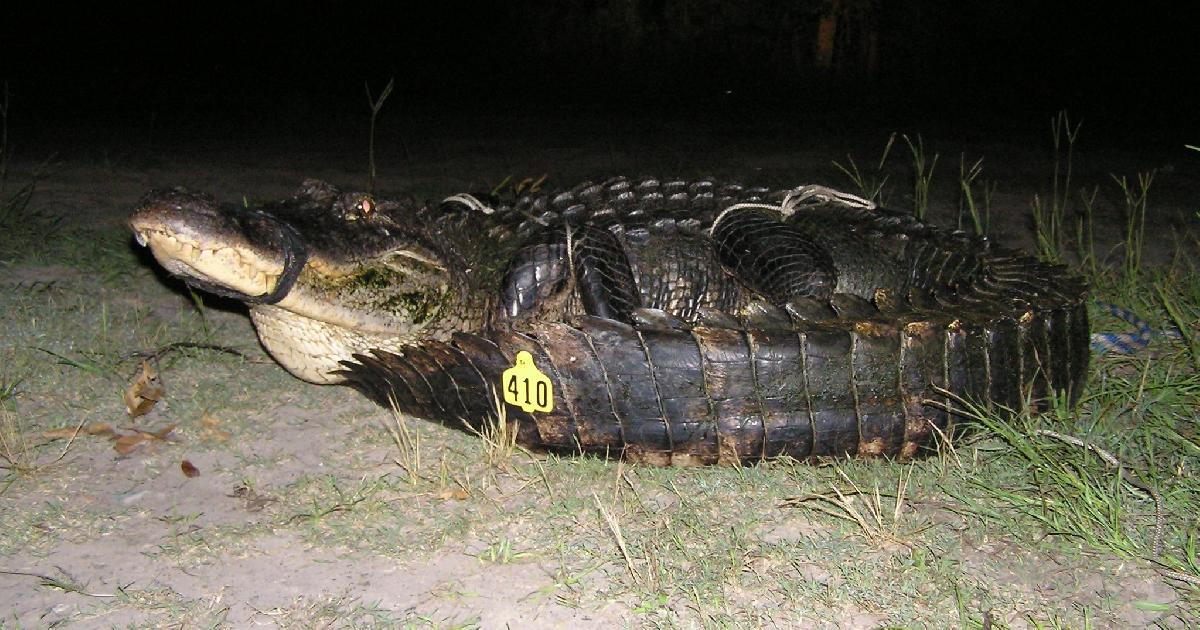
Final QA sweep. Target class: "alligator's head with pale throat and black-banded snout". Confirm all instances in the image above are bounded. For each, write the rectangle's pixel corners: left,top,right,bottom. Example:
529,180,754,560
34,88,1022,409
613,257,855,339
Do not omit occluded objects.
130,180,486,383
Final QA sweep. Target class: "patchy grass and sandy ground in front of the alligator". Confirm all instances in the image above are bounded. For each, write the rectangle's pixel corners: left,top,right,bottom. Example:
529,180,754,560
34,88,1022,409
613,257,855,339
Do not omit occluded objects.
0,120,1200,629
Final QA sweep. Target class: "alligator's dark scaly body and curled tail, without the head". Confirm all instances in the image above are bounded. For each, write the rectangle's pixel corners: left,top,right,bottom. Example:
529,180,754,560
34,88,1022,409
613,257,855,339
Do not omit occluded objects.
343,179,1088,464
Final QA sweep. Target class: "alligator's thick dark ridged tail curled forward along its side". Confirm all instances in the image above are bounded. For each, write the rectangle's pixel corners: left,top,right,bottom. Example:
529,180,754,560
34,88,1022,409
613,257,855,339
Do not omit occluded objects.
343,295,1088,466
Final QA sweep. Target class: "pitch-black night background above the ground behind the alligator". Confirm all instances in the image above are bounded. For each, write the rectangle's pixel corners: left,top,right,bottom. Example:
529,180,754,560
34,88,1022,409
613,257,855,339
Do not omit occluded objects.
0,0,1200,145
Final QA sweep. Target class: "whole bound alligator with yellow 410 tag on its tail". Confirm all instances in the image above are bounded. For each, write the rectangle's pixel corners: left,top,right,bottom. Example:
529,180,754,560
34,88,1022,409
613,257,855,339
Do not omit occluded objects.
130,178,1088,464
